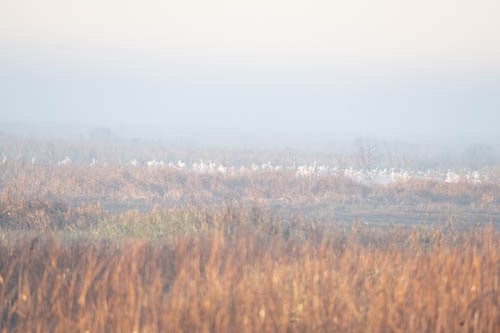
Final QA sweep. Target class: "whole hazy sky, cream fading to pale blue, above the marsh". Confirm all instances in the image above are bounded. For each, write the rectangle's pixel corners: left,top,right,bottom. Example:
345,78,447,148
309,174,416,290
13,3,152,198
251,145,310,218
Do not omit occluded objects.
0,0,500,139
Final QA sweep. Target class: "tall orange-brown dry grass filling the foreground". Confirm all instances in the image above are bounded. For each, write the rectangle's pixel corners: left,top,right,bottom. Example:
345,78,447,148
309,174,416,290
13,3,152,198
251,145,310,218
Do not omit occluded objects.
0,221,500,332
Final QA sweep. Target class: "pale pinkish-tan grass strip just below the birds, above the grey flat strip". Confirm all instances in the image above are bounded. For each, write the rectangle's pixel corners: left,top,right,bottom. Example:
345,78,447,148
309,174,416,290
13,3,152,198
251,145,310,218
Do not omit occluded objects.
0,162,500,208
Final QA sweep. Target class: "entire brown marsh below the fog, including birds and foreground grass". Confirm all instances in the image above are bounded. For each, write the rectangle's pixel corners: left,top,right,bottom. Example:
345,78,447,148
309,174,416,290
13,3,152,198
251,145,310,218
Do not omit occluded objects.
0,136,500,332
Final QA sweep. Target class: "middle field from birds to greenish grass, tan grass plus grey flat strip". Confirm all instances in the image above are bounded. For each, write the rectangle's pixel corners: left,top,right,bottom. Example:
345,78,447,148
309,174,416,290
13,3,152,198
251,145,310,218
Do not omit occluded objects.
0,162,500,231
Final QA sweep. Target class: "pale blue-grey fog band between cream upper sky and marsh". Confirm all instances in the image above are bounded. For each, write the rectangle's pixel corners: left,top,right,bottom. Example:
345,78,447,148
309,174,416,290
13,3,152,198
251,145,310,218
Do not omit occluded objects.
0,69,500,147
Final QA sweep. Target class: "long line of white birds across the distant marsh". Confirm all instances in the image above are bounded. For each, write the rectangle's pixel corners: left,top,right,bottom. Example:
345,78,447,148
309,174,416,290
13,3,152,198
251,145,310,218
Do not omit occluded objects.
0,154,493,184
